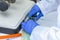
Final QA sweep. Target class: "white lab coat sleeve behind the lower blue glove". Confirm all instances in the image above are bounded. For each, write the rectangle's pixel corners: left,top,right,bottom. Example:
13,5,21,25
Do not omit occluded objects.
30,26,60,40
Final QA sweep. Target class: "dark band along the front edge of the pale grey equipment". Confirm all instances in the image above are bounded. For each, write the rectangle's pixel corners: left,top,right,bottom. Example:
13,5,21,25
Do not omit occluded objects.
0,25,21,34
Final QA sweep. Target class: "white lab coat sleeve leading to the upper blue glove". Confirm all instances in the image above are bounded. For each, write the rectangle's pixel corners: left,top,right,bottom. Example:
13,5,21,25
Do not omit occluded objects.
36,0,58,13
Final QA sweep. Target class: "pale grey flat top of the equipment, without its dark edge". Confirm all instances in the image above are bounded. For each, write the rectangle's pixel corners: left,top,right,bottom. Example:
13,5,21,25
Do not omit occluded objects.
0,1,34,29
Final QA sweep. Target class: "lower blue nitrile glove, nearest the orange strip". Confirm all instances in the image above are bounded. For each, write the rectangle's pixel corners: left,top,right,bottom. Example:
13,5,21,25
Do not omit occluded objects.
22,20,38,34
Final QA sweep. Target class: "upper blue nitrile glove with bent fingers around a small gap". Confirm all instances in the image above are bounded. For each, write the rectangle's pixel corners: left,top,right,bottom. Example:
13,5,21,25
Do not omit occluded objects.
28,5,43,20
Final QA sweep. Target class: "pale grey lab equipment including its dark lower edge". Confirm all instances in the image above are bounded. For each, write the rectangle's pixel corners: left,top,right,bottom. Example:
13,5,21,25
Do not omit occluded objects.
0,0,35,36
